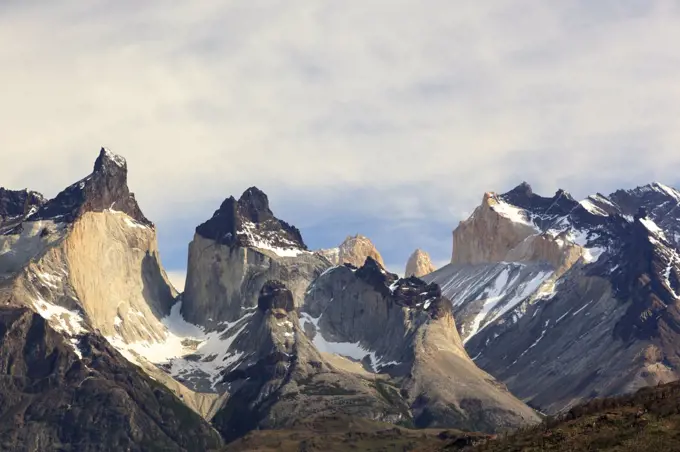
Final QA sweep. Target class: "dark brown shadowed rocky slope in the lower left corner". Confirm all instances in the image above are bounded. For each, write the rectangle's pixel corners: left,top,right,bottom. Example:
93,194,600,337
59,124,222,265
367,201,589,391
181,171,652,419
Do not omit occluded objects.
0,306,222,452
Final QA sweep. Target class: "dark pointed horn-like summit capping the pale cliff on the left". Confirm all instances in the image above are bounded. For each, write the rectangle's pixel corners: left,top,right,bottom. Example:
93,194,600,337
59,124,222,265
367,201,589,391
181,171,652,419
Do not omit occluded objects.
27,148,153,227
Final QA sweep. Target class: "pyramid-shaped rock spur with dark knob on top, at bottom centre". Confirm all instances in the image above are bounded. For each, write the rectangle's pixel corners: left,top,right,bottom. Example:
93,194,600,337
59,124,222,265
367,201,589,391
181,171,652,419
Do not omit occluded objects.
213,281,410,441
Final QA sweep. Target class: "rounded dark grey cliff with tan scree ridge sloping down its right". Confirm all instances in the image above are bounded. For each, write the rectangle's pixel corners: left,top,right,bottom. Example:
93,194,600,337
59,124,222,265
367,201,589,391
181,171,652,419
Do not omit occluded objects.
301,257,538,432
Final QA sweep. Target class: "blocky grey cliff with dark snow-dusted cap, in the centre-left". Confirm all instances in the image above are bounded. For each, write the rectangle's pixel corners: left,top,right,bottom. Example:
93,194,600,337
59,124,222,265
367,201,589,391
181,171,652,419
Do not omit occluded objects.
182,187,331,327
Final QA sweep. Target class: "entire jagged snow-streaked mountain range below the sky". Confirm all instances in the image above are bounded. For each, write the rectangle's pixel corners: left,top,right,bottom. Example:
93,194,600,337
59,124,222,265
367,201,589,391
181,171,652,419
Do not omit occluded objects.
0,149,680,451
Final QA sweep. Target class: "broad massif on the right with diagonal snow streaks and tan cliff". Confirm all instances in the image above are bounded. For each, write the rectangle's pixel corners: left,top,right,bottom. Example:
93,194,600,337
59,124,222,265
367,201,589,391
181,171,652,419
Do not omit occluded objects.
425,184,680,413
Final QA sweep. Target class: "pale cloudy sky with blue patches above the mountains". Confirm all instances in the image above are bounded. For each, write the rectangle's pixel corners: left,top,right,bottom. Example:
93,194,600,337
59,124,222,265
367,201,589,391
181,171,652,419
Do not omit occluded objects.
0,0,680,288
